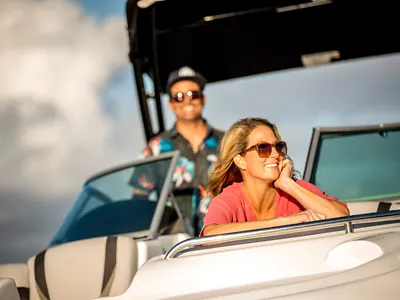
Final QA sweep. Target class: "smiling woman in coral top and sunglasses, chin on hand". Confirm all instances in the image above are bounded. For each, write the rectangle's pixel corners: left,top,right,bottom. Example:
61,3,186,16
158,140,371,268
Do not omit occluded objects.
200,118,349,236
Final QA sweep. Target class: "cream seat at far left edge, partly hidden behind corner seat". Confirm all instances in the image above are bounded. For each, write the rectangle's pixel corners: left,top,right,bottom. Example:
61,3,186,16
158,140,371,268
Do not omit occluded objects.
0,264,29,300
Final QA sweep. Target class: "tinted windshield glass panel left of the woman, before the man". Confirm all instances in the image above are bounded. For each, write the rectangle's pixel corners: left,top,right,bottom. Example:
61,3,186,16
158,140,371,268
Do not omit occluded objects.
51,158,171,245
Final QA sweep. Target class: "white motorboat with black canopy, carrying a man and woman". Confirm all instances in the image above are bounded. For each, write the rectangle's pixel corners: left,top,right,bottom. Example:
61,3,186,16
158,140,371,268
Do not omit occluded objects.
0,0,400,300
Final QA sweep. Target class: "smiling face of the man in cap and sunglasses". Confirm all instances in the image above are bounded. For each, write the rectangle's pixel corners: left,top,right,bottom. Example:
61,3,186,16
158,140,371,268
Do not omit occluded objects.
168,80,205,121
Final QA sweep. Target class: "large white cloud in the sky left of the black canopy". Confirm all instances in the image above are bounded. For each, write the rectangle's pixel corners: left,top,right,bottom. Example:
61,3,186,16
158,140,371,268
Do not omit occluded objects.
0,0,133,198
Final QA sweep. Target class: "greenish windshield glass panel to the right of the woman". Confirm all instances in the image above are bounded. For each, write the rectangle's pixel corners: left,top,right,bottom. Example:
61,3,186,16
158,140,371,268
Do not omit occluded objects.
311,130,400,202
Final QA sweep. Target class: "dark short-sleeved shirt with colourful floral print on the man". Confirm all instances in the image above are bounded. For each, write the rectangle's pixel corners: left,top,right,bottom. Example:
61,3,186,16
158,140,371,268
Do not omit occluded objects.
130,121,224,234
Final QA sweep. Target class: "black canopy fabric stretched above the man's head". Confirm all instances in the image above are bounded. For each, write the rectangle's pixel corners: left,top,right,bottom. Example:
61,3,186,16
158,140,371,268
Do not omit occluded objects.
127,0,400,92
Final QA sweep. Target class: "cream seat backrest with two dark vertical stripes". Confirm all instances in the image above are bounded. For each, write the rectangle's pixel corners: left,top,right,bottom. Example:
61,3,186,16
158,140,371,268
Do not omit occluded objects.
28,236,138,300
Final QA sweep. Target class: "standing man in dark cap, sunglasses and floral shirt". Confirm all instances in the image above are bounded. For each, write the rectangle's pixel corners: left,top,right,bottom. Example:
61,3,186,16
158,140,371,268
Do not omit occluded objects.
130,66,224,236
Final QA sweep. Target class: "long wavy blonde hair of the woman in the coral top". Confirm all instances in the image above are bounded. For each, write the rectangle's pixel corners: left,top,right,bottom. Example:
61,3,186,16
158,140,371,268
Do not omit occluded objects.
208,118,281,197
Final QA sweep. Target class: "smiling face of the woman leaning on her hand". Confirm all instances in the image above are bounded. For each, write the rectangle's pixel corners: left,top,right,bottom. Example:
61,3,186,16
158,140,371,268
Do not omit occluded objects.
243,126,283,182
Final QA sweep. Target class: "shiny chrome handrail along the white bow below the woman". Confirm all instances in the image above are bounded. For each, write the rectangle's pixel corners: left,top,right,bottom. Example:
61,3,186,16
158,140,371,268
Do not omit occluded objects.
164,211,400,259
